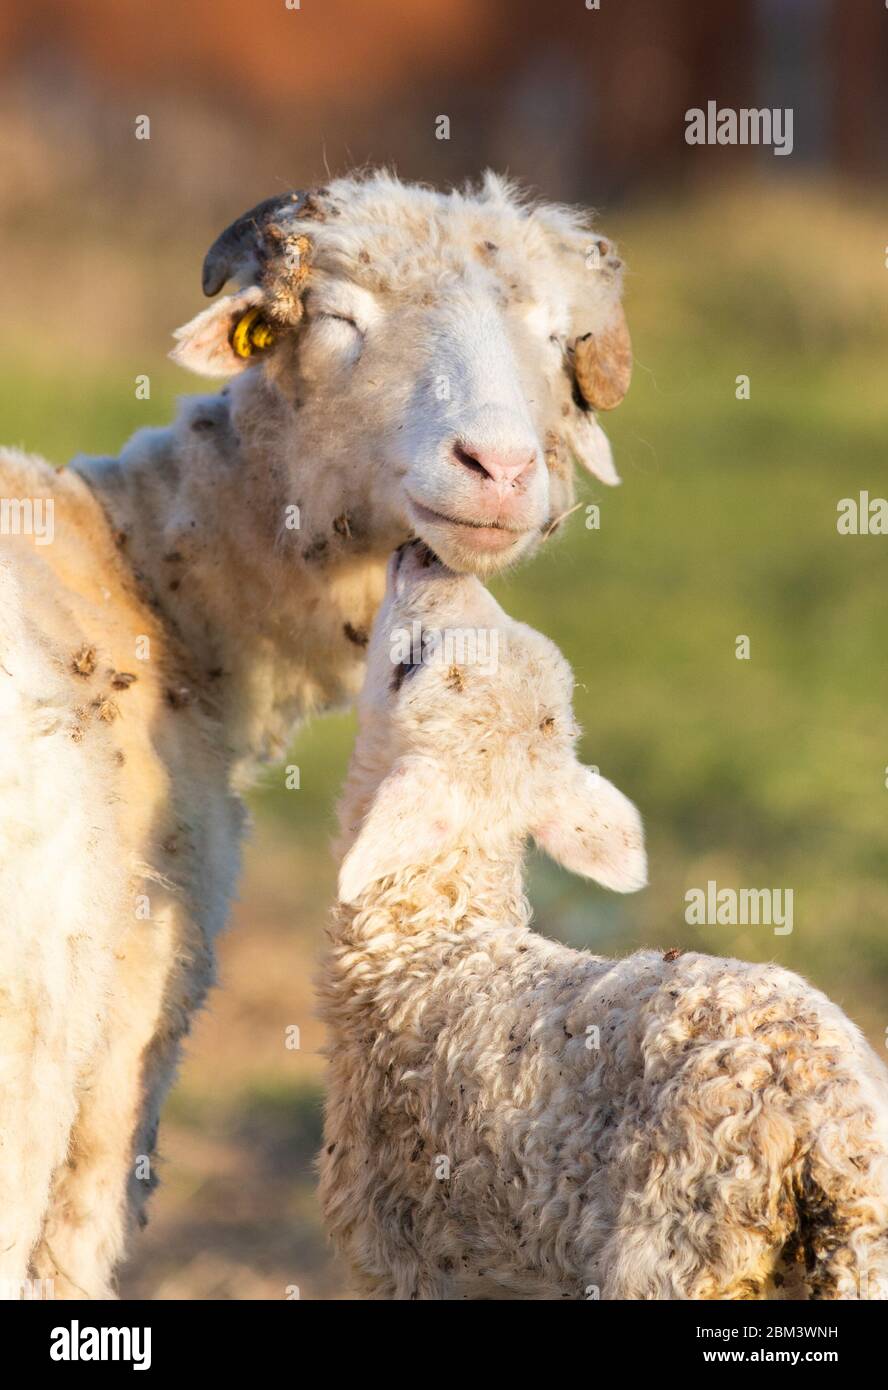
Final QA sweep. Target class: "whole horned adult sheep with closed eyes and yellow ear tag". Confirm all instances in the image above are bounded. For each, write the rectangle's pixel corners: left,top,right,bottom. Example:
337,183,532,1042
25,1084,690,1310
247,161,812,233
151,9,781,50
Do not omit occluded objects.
0,174,631,1298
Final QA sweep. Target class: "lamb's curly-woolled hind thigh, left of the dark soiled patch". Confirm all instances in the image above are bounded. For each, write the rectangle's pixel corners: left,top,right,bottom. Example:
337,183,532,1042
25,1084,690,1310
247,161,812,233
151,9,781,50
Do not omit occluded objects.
602,1037,800,1300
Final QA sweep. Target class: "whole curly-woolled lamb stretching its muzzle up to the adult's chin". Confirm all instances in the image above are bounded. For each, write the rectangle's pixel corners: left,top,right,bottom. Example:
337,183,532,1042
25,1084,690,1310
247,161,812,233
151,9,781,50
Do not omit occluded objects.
320,542,888,1300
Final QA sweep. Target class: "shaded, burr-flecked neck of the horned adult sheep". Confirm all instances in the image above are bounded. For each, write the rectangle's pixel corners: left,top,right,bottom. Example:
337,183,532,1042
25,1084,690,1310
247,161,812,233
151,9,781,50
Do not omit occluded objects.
74,374,404,787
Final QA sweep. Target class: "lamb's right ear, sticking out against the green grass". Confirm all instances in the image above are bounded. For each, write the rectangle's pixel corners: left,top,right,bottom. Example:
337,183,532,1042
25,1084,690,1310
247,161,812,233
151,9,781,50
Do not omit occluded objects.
532,762,648,892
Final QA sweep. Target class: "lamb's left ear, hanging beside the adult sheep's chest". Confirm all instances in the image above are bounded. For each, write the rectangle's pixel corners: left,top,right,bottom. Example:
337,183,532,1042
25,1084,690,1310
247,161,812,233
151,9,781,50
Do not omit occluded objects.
339,758,459,904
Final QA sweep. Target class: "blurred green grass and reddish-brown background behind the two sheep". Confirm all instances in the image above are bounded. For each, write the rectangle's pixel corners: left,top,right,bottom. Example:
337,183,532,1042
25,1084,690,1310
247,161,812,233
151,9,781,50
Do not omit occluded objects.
0,0,888,1298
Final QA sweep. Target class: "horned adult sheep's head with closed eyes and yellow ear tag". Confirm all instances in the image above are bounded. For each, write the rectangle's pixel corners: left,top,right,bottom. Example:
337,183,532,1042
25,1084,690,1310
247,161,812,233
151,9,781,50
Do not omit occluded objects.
174,175,630,574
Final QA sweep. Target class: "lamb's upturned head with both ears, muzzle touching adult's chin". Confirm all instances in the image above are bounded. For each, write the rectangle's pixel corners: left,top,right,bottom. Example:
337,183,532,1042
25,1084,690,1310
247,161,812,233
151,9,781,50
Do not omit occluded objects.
340,542,646,902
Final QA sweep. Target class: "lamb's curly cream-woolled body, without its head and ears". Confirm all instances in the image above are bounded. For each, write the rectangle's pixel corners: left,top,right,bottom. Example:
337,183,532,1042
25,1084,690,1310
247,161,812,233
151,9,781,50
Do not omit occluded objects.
321,866,888,1298
